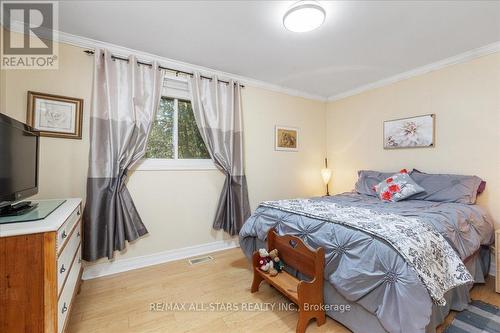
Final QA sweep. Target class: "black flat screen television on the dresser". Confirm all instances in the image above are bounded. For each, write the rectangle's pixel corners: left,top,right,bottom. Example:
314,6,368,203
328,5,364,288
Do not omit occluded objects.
0,113,39,216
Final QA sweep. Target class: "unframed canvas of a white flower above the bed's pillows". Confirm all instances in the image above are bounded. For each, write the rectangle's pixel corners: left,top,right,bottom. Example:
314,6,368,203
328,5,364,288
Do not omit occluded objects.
384,114,436,149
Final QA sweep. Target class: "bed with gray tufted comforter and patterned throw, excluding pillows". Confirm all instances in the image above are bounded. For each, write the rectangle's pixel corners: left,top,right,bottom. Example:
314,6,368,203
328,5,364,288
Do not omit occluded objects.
240,191,493,333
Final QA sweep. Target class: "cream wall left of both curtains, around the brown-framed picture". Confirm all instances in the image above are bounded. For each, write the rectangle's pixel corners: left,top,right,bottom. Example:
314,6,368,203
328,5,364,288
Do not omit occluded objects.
0,42,93,202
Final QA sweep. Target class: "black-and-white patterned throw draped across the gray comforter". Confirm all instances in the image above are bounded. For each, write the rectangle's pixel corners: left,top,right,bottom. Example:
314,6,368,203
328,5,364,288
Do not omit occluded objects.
261,199,474,305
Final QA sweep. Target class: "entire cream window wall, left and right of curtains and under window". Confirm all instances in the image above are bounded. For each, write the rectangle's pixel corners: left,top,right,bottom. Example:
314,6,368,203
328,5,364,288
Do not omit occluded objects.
0,35,326,259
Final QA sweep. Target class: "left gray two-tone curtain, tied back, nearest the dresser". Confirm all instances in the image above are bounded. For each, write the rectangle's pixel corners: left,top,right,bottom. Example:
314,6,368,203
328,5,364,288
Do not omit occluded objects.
83,50,163,261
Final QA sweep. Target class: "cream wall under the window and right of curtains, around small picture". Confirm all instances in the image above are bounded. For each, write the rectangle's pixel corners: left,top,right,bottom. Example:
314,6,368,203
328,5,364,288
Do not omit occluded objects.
124,86,326,257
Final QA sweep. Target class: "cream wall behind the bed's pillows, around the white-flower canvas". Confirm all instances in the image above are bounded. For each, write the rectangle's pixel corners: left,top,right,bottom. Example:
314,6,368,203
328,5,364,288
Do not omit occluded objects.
327,53,500,226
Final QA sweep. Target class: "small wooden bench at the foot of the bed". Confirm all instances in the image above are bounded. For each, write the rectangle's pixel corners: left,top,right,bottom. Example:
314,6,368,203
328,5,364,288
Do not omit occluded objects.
251,229,326,333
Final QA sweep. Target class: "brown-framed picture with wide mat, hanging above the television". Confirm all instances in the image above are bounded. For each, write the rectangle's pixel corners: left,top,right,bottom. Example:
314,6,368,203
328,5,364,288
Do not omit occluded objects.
26,91,83,139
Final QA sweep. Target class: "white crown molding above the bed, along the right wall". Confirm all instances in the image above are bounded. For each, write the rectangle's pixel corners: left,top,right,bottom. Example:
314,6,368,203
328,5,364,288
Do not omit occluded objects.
327,42,500,102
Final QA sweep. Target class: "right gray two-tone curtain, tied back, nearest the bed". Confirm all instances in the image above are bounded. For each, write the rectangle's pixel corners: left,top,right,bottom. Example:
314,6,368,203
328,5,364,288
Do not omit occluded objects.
190,73,250,235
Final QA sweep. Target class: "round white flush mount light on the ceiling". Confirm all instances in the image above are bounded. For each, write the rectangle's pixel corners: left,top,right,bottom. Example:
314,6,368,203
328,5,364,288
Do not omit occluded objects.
283,1,326,32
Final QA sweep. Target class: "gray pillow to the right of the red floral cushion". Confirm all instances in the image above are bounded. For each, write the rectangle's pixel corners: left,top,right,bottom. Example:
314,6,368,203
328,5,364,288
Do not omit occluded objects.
411,170,482,204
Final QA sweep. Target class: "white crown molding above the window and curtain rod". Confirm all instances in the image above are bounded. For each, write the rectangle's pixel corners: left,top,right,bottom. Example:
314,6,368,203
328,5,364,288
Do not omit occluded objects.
55,31,327,102
